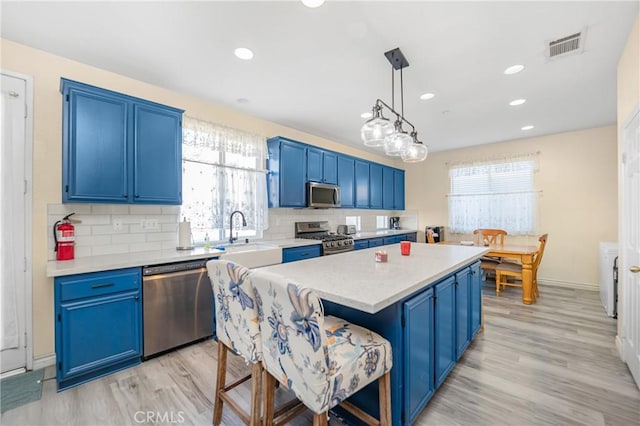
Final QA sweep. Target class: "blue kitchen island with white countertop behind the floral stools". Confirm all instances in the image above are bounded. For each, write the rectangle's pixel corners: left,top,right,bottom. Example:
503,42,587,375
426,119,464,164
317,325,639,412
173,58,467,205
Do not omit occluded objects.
262,243,487,425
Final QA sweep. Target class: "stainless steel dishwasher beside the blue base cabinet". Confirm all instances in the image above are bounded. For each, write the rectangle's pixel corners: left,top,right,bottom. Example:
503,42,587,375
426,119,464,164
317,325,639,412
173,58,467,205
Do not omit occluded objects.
142,260,214,358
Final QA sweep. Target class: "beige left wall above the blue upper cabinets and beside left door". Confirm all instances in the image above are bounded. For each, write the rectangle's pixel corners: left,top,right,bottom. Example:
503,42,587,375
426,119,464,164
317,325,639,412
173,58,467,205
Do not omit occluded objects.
0,39,402,358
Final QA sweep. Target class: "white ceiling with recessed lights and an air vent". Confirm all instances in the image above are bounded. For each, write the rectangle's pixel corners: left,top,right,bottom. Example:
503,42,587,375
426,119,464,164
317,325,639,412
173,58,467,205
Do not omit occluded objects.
1,0,638,152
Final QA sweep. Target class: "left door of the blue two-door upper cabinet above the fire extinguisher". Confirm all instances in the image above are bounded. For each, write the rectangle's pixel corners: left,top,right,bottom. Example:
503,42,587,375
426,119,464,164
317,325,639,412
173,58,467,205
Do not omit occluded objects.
62,86,130,203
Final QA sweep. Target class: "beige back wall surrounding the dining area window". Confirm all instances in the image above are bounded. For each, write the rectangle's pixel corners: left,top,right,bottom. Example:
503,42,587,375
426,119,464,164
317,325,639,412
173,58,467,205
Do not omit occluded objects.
405,126,618,288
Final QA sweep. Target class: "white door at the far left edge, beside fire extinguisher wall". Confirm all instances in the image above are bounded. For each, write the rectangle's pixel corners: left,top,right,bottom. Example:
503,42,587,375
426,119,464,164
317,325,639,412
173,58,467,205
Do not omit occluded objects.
0,73,27,373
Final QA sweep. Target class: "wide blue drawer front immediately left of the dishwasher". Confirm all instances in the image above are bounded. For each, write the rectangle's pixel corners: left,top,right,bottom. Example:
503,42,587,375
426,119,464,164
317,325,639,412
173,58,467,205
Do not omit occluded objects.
56,268,140,302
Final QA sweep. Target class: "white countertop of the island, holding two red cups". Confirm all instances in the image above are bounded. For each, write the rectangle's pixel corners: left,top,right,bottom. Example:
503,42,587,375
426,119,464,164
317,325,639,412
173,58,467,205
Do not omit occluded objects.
259,243,488,313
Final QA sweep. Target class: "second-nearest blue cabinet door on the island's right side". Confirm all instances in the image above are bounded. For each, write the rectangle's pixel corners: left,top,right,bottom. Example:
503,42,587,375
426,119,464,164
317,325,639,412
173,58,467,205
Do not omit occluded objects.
434,276,456,388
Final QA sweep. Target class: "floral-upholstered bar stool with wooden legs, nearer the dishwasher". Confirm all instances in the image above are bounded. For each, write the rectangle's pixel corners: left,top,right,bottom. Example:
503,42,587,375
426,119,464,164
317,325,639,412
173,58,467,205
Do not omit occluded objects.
207,260,263,425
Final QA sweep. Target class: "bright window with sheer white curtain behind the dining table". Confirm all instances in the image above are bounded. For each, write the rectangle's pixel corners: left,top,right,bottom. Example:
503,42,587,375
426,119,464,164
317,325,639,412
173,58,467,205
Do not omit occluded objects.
449,154,538,235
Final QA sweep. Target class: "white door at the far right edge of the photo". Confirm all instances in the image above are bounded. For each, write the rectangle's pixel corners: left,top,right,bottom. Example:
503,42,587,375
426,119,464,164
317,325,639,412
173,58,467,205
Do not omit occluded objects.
619,108,640,387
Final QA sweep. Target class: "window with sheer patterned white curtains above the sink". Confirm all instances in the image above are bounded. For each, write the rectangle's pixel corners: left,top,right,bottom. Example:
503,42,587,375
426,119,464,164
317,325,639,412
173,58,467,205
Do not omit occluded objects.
181,117,269,243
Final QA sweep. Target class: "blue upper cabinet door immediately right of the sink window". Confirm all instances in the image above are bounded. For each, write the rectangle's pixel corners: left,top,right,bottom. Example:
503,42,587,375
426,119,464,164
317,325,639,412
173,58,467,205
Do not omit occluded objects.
280,141,307,207
